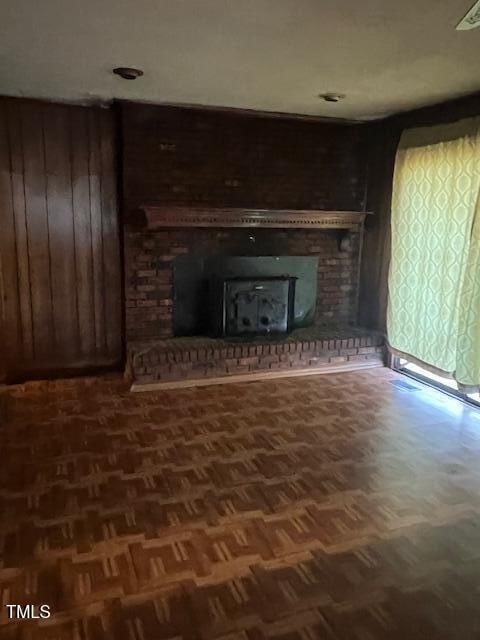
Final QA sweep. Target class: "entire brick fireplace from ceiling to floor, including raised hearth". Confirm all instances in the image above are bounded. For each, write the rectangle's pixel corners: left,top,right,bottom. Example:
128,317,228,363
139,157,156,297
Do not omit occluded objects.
119,102,383,386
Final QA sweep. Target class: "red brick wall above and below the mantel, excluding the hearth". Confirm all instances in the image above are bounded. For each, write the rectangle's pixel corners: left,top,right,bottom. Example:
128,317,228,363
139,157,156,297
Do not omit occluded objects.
121,103,366,340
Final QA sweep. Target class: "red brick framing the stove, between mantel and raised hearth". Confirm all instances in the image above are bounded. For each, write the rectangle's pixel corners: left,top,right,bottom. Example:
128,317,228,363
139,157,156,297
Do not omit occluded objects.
125,229,358,340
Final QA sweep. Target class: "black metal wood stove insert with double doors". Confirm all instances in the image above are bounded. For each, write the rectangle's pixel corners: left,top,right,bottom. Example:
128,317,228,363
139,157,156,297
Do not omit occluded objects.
210,276,296,337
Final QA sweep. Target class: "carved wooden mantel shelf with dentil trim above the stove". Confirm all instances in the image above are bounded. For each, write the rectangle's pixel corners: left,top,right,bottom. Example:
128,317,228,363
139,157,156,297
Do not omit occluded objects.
133,205,368,231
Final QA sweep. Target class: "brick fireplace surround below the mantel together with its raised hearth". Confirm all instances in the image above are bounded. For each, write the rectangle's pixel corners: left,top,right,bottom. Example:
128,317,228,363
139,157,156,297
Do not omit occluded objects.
125,220,384,389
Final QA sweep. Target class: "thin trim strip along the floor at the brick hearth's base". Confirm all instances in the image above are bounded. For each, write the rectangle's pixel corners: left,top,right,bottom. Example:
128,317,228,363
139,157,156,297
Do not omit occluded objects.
130,361,384,393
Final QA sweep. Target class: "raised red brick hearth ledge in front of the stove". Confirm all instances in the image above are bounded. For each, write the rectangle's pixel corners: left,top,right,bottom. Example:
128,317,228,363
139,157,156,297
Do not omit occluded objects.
128,327,384,385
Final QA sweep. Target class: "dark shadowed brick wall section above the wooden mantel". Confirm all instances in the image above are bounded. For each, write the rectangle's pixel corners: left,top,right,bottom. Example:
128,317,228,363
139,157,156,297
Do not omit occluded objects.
122,103,367,210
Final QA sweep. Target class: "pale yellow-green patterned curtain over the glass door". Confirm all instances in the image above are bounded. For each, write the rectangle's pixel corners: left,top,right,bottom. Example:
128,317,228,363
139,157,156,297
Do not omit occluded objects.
387,118,480,387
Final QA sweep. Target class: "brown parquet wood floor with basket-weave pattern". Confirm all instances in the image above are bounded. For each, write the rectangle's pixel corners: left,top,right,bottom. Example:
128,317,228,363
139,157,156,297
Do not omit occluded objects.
0,369,480,640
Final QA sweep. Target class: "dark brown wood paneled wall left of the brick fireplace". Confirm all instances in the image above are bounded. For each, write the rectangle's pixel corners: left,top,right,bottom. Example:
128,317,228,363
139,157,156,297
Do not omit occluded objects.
0,98,122,379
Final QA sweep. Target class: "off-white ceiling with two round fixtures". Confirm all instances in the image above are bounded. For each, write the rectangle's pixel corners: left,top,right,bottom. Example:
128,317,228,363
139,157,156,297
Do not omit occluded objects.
0,0,480,118
